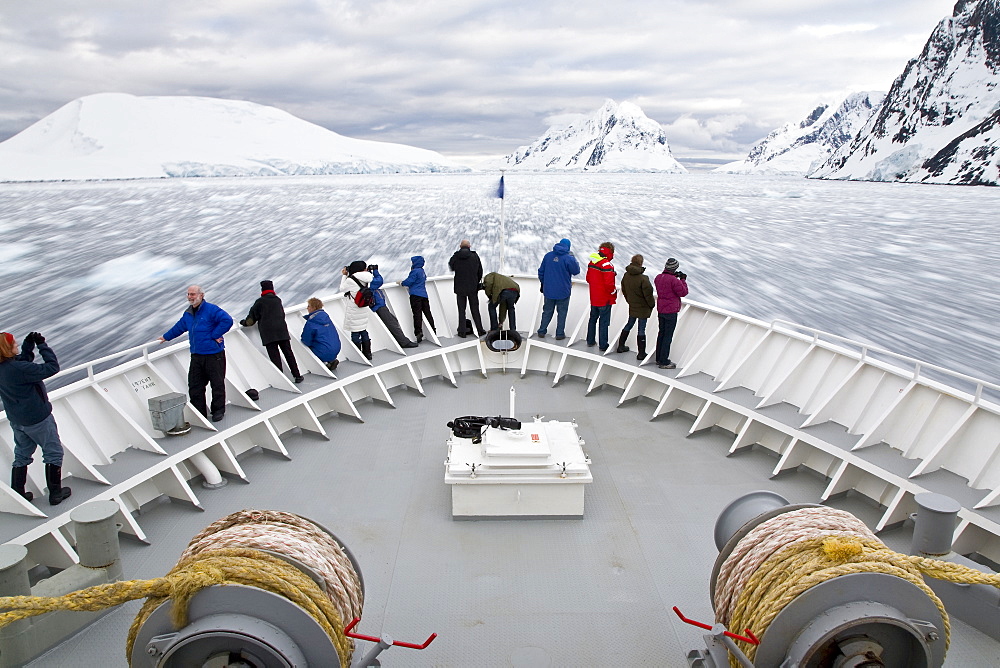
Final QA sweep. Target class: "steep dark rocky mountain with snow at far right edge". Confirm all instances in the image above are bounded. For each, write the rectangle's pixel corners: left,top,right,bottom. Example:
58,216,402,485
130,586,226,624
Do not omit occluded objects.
810,0,1000,185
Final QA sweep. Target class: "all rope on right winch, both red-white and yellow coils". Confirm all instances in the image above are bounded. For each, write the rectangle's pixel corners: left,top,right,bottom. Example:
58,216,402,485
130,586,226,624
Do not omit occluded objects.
714,506,1000,667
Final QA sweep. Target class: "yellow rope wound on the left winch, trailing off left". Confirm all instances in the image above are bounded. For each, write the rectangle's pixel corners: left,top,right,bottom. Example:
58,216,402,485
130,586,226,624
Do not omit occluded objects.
0,549,353,666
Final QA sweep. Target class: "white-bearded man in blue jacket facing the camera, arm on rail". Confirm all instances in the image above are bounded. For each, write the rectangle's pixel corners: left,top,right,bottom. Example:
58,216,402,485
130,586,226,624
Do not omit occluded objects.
159,285,233,422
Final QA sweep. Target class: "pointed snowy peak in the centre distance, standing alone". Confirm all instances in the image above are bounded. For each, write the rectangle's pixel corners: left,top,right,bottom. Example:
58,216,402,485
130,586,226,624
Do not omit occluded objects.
499,100,687,173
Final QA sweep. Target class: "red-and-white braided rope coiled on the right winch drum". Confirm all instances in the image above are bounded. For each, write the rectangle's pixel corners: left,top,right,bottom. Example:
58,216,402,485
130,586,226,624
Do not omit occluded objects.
714,506,877,633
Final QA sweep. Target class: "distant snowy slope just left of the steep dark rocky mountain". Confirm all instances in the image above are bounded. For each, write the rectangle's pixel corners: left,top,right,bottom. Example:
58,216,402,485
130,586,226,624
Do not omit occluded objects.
713,92,885,176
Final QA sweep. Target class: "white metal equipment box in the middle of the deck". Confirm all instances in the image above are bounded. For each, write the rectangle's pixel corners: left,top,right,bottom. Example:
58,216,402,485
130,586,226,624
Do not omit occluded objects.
444,418,594,519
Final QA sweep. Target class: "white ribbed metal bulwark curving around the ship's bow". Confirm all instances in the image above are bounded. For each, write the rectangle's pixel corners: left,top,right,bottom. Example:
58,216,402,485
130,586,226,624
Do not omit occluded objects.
0,276,1000,568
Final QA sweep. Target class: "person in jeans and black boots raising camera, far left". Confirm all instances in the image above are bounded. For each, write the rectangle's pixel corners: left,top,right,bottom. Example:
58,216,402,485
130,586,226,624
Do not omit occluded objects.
0,332,72,506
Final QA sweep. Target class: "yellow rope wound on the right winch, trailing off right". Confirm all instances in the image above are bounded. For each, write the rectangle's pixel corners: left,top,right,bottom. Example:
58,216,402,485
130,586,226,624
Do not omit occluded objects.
729,535,1000,666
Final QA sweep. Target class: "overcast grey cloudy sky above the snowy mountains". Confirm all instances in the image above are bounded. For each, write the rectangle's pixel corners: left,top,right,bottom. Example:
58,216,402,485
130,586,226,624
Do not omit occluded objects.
0,0,954,165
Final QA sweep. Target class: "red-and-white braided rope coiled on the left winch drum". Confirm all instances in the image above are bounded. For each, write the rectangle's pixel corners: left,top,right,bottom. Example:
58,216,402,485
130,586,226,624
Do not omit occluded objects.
181,509,364,621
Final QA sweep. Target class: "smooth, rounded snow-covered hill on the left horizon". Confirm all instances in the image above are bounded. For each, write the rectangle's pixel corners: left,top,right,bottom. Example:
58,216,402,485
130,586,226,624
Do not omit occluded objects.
0,93,469,181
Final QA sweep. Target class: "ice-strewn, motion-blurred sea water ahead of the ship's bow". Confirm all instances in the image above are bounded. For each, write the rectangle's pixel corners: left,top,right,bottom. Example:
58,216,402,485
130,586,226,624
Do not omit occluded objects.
0,173,1000,382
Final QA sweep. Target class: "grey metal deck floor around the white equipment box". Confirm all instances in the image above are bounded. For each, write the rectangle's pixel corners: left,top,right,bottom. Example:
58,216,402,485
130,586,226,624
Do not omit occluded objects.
23,371,1000,668
